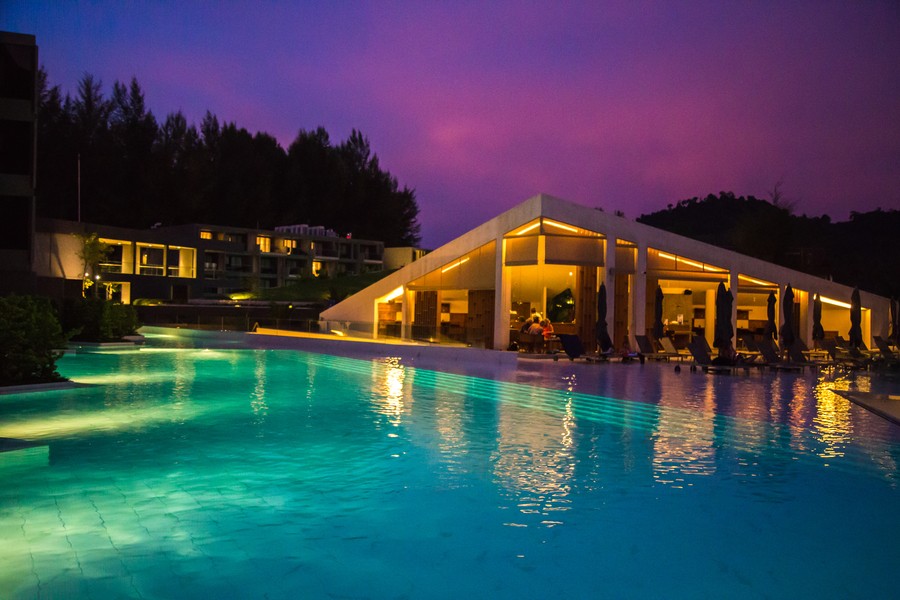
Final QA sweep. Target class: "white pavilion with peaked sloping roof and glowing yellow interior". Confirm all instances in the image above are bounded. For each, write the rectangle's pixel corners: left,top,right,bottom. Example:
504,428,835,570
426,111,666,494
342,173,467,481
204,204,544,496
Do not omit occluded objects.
321,195,889,349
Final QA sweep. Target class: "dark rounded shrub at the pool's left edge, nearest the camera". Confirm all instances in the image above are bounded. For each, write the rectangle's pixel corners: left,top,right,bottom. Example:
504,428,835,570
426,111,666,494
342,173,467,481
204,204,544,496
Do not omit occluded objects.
0,296,66,385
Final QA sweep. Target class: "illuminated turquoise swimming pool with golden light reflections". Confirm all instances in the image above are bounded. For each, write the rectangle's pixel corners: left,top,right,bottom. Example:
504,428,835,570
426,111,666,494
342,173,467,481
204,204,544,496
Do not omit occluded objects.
0,336,900,598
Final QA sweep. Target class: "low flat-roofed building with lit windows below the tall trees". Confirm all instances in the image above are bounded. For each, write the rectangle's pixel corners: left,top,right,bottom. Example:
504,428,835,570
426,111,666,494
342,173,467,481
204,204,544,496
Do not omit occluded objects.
34,219,384,303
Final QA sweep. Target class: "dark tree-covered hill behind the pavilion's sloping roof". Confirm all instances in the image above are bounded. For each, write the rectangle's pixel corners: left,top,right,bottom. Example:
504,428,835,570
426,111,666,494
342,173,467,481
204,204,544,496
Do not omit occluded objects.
638,193,900,297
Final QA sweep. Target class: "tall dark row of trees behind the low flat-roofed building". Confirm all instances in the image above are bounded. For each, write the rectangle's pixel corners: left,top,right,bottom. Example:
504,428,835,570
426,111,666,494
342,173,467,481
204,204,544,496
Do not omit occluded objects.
37,70,420,245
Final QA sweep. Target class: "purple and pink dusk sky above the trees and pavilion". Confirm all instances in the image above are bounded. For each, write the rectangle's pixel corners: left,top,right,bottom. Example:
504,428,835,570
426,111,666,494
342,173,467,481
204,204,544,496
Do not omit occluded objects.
7,0,900,247
